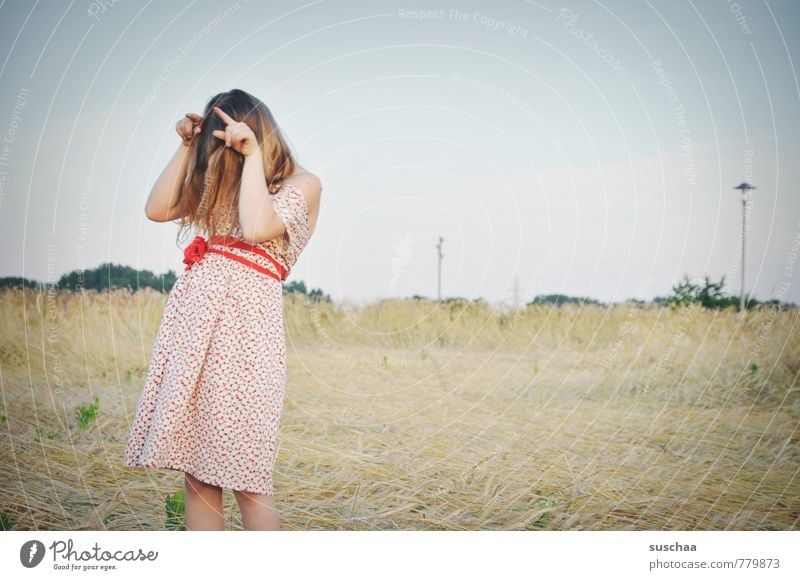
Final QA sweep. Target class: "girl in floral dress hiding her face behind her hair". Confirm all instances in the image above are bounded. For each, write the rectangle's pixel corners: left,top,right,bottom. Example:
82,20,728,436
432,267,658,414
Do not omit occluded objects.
124,89,322,530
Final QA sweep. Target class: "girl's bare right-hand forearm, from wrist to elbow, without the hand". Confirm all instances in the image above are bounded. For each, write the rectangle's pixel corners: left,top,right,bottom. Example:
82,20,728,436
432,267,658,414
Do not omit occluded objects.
239,146,285,244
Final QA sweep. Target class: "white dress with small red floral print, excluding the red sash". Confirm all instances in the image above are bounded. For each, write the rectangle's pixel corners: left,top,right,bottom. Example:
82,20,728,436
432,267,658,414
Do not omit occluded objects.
124,184,309,495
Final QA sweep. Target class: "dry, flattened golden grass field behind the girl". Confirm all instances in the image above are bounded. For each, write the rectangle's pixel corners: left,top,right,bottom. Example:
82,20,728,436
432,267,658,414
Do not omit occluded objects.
0,290,800,530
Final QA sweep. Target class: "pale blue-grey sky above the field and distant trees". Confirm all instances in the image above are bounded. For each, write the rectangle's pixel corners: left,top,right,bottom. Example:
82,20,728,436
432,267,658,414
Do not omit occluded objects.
0,0,800,304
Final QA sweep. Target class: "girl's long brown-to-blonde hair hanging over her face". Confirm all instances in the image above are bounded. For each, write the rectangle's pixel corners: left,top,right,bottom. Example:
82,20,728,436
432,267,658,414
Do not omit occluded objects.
178,89,295,239
